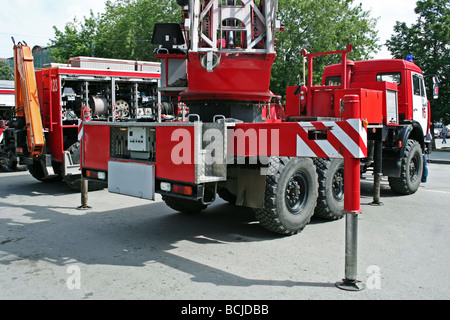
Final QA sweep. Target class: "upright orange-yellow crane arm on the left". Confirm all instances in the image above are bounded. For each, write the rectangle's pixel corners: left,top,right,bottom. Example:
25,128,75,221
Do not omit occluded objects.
14,43,45,158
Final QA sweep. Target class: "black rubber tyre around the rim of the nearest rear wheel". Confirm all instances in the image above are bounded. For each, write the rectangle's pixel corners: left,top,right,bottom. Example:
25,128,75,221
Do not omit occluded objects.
254,157,318,236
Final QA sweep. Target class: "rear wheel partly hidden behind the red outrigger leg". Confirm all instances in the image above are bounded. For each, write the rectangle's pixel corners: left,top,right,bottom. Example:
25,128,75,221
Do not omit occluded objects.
314,158,344,220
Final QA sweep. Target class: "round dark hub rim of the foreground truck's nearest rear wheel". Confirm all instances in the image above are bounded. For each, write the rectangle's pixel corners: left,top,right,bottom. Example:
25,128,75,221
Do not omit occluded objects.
285,172,308,214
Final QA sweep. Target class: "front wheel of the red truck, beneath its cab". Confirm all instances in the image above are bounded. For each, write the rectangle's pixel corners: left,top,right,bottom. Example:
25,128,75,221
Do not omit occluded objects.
388,140,423,195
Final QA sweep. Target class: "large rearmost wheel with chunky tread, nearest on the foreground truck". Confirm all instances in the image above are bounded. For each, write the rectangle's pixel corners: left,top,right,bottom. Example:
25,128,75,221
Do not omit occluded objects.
254,157,318,235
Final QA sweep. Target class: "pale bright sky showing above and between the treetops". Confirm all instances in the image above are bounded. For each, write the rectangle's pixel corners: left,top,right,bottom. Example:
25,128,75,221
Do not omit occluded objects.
0,0,417,59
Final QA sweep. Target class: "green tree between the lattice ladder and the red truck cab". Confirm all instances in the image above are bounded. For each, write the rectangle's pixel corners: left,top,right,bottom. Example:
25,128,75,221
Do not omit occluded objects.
271,0,380,96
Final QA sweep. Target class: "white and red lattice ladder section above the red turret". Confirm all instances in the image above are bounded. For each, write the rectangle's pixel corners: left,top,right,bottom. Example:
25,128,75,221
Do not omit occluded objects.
187,0,279,53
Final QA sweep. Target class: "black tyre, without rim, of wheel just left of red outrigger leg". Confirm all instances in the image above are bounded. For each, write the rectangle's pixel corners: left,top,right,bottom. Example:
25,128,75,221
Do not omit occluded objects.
314,158,344,220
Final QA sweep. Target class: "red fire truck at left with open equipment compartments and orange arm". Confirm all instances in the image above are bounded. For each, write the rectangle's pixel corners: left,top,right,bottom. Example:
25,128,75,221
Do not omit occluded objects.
0,43,165,189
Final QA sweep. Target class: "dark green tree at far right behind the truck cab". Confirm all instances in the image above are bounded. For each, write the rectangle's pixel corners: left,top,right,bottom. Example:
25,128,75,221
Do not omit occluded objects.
386,0,450,124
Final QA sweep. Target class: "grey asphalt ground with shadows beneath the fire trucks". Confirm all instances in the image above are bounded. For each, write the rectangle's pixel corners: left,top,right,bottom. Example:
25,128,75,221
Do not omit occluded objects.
0,164,450,301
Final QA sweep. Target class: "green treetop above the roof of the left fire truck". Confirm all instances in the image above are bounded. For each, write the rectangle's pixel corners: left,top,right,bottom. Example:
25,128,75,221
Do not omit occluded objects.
47,0,181,62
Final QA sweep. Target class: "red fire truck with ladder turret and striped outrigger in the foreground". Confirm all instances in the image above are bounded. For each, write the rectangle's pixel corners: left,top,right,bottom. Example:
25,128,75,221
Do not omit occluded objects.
82,0,429,235
